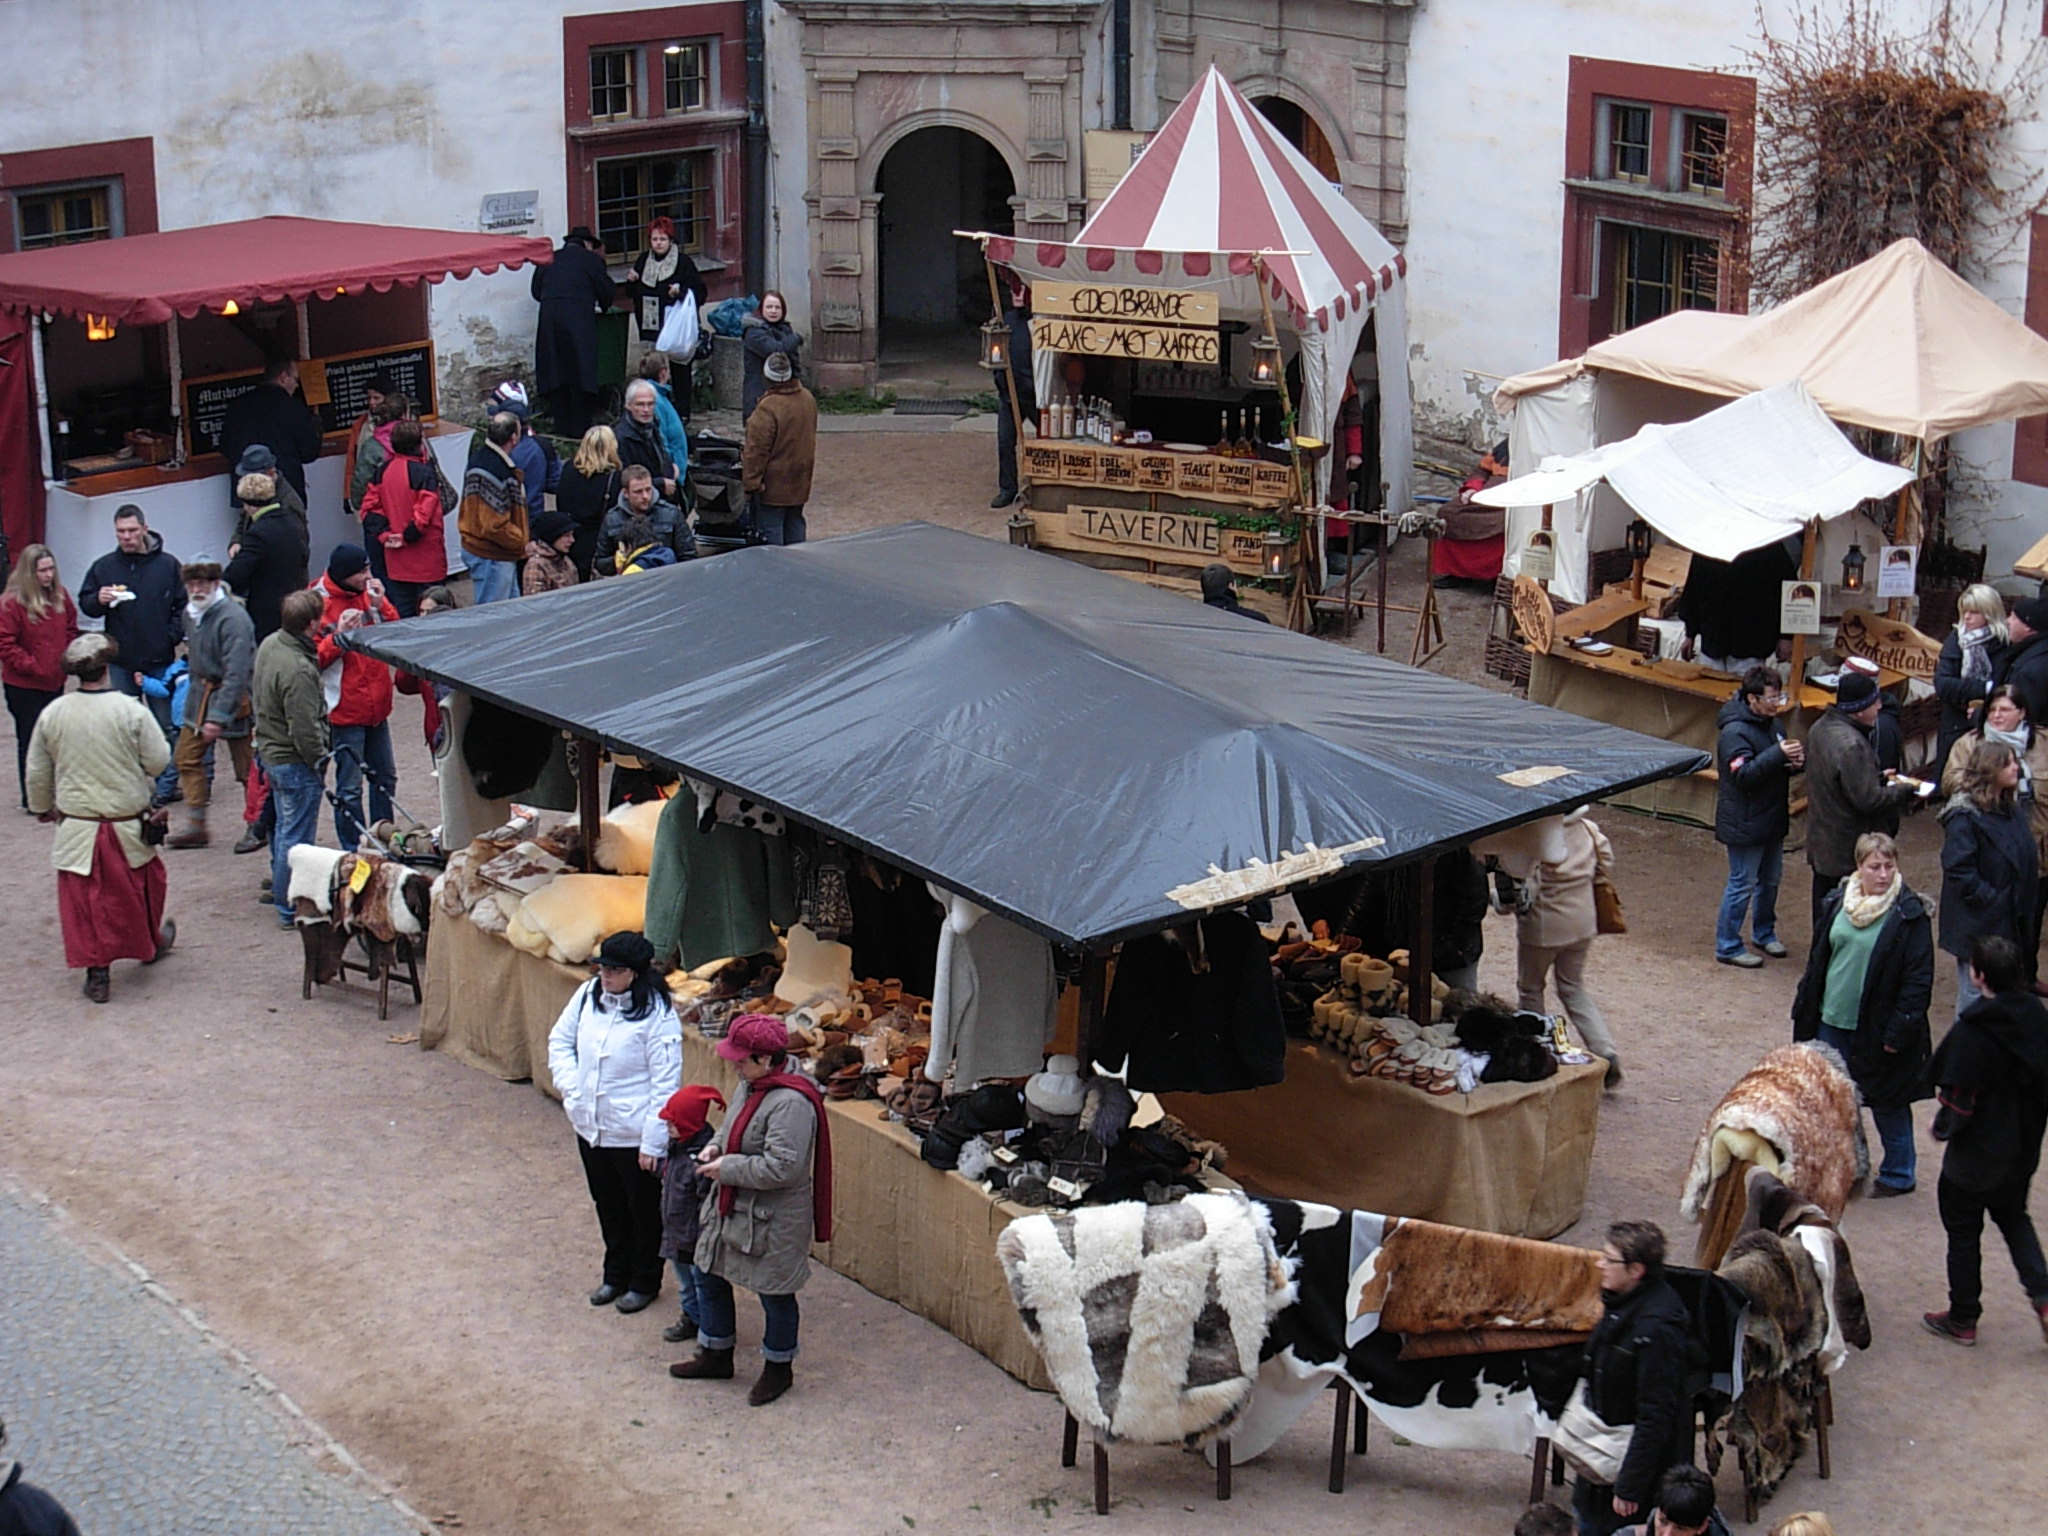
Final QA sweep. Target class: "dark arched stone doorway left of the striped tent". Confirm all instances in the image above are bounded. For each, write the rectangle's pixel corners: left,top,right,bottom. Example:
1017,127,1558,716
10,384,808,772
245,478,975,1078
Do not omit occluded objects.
874,127,1016,389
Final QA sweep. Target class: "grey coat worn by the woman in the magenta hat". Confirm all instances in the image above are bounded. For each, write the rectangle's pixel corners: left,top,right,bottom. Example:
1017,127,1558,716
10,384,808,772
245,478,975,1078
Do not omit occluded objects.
696,1087,817,1296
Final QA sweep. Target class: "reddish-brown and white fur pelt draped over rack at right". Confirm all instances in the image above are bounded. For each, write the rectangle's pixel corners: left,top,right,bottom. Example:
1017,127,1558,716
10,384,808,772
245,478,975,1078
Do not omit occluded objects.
1679,1044,1870,1221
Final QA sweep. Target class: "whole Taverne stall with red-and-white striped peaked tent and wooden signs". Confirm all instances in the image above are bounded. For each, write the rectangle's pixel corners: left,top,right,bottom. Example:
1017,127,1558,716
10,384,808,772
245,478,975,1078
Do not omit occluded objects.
969,68,1413,621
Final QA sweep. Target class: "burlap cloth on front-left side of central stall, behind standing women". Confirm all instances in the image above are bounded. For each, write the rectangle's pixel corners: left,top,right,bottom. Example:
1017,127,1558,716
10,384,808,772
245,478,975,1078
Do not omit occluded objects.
420,915,1051,1391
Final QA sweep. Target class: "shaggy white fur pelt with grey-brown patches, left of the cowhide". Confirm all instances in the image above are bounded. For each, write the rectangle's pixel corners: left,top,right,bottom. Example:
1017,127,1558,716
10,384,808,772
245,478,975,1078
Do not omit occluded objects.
995,1192,1294,1446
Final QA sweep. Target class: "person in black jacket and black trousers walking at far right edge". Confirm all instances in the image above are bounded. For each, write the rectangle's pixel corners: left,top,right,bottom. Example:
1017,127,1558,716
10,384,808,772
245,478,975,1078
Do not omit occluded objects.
1921,938,2048,1343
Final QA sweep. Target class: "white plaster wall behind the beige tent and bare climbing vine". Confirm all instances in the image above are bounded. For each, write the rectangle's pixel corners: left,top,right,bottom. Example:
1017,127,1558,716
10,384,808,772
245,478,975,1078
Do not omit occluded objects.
1407,0,2048,573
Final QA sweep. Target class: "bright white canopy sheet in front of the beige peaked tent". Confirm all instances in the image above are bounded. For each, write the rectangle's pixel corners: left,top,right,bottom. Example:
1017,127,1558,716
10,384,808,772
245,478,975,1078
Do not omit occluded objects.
1473,379,1913,561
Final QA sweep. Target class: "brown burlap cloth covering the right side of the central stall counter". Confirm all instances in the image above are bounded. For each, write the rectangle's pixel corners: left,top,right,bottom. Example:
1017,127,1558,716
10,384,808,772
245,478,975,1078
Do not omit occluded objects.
1159,1040,1608,1237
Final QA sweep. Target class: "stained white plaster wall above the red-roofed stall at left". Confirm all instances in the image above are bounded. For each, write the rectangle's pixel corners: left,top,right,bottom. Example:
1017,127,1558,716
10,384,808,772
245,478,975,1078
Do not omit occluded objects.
0,0,696,408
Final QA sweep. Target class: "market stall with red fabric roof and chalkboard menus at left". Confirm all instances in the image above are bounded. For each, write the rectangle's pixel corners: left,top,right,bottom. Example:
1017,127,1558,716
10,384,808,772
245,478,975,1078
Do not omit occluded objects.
0,217,549,575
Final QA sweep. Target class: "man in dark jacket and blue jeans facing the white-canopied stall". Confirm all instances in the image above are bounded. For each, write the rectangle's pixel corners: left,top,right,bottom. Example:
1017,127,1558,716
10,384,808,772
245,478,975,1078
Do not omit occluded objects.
1714,666,1806,971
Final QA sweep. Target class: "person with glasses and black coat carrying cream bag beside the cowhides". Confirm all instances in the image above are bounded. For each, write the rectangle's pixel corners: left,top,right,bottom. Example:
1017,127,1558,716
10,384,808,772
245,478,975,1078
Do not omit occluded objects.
1571,1221,1694,1536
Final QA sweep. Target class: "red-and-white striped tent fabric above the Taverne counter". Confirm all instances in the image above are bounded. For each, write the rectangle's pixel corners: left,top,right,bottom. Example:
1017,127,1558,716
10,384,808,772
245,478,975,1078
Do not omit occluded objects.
981,66,1413,512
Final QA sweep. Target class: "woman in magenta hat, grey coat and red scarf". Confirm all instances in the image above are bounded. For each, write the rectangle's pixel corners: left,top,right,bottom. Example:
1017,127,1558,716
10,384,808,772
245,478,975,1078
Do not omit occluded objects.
668,1014,831,1407
